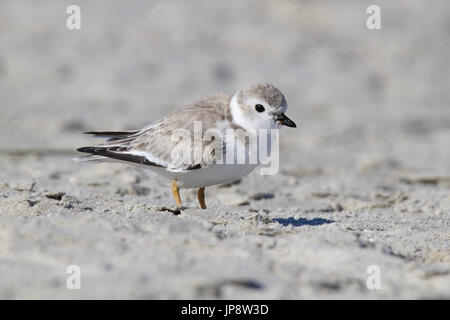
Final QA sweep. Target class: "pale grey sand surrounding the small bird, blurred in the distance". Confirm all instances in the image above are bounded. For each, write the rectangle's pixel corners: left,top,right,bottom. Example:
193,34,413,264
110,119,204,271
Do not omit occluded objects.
0,0,450,299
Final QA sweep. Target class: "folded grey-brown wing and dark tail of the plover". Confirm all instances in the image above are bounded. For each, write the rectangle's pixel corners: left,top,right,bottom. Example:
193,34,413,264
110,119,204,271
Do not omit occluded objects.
77,94,231,171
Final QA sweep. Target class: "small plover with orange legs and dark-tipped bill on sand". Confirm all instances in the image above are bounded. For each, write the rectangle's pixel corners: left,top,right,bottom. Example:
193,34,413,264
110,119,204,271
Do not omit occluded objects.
77,83,296,209
